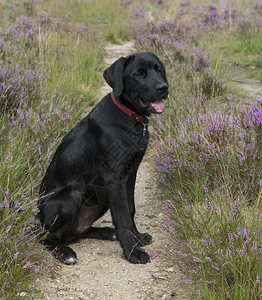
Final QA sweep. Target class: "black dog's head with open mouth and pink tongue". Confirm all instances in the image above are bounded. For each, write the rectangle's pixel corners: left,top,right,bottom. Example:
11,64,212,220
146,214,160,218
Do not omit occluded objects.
104,52,168,114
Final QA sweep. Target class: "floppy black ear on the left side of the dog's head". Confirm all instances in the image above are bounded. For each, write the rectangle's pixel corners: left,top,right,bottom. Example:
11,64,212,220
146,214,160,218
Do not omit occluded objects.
103,57,126,96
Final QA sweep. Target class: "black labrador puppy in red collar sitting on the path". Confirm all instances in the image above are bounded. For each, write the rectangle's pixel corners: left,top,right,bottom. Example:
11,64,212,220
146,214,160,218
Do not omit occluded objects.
38,52,168,264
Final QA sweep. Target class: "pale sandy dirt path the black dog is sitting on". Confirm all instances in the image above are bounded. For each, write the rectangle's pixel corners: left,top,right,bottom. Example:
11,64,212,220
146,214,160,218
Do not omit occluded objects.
39,42,192,300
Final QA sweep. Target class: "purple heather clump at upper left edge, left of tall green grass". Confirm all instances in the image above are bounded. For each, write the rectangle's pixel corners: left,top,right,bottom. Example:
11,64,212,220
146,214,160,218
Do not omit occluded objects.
0,17,44,114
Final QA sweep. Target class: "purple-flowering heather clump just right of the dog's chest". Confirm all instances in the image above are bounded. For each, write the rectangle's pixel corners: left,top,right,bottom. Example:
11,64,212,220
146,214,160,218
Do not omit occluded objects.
153,95,262,202
